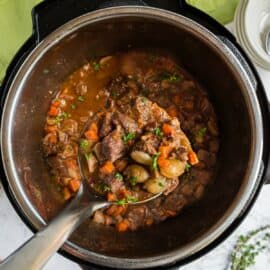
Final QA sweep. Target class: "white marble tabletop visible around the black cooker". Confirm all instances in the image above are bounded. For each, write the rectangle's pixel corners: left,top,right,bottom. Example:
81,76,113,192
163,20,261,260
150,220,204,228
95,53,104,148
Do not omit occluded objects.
0,25,270,270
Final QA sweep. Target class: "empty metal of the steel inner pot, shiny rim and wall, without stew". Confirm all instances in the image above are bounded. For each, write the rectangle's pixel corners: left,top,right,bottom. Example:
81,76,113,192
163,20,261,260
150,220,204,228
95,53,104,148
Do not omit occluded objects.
1,6,263,269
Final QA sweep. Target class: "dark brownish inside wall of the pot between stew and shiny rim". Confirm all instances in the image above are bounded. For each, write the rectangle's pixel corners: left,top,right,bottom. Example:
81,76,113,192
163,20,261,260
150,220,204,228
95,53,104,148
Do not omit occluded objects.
7,17,251,258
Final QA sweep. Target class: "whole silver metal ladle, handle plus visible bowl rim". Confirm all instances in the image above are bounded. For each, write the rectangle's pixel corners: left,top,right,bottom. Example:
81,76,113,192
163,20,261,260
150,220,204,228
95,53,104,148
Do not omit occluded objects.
0,116,162,270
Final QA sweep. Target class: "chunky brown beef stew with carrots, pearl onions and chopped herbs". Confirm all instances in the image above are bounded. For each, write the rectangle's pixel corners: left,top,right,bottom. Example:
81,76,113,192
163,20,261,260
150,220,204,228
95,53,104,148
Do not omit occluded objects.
43,51,219,231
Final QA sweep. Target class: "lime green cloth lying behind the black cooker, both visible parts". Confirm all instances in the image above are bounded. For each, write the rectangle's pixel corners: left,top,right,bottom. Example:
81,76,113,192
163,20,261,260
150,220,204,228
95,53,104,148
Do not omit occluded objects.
0,0,238,81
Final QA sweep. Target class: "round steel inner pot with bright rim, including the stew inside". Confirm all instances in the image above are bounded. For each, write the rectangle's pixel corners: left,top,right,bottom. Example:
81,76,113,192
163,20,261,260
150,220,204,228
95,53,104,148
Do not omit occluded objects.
1,4,265,269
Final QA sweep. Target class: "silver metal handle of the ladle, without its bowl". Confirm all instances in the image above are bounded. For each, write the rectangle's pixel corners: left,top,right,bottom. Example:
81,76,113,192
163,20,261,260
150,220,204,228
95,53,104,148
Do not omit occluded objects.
0,202,108,270
